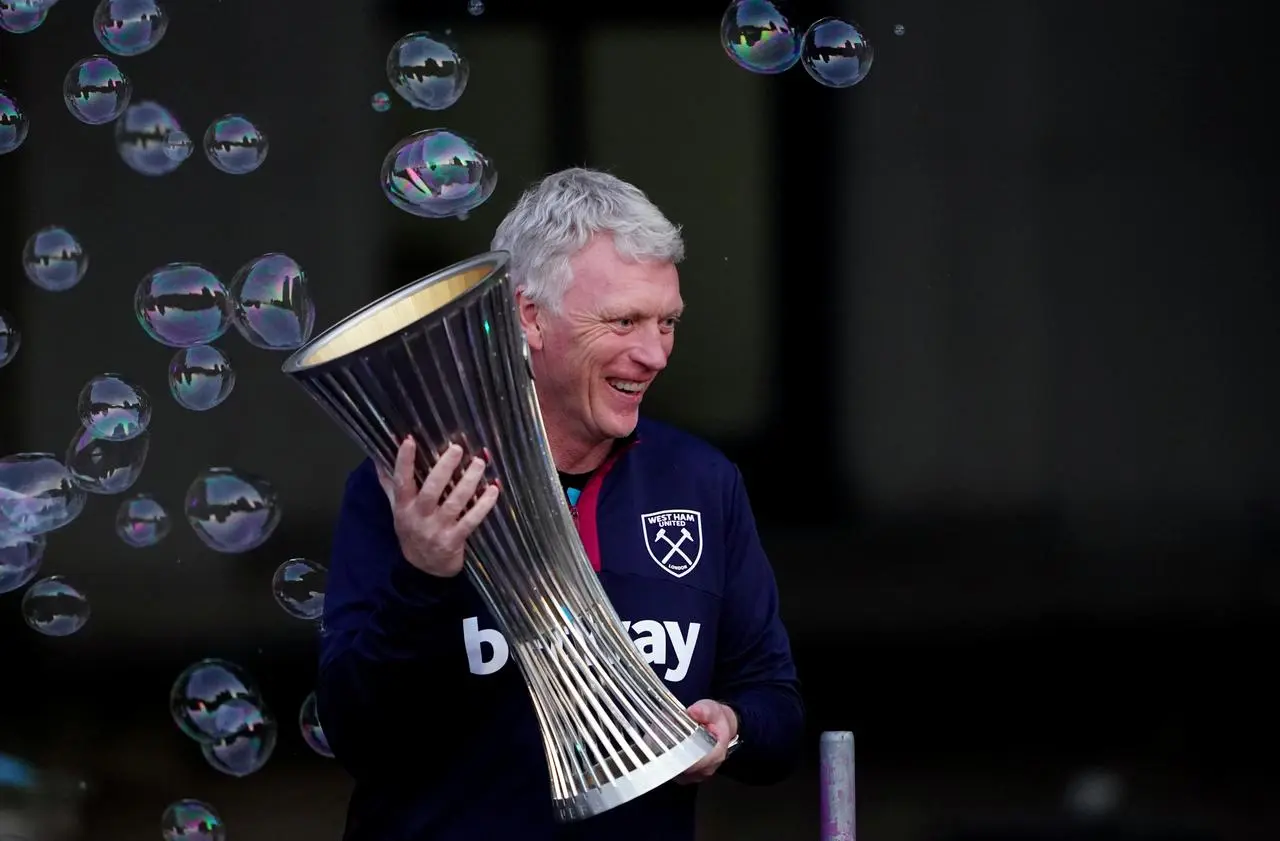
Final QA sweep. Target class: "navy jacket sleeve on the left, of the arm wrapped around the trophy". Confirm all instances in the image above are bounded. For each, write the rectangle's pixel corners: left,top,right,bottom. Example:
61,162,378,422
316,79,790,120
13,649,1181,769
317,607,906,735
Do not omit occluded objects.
316,461,483,781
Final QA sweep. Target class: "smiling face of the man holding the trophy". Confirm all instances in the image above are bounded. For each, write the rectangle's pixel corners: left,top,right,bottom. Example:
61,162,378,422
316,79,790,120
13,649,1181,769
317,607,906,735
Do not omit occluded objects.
520,234,684,472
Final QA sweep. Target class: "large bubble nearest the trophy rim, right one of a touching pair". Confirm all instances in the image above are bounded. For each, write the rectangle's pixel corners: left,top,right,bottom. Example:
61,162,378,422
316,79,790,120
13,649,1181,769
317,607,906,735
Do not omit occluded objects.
229,253,316,351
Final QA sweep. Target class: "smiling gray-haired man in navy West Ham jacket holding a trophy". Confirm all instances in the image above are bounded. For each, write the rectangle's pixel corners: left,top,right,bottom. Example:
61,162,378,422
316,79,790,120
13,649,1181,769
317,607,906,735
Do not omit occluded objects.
316,169,804,841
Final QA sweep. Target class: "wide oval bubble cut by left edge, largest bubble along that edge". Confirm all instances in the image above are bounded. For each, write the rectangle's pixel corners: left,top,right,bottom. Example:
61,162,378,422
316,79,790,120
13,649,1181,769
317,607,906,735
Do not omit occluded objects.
0,453,88,535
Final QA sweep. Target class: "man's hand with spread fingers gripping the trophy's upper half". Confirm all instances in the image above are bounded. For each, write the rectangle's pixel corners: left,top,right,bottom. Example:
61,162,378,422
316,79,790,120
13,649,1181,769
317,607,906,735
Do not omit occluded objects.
378,437,499,579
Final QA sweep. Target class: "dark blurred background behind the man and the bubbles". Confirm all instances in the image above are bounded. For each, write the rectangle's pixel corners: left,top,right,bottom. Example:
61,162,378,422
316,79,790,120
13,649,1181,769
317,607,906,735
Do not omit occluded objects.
0,0,1280,841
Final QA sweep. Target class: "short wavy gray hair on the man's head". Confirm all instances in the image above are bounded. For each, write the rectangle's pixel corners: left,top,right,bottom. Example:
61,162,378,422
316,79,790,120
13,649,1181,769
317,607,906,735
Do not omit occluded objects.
490,168,685,312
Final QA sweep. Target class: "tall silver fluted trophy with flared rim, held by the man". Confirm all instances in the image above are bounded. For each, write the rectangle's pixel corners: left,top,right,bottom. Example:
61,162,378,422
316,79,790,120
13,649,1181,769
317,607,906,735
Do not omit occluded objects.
284,252,716,822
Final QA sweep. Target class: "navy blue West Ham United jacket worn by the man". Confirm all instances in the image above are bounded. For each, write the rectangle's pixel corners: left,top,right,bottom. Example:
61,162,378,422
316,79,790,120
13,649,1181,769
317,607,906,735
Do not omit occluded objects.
316,420,804,841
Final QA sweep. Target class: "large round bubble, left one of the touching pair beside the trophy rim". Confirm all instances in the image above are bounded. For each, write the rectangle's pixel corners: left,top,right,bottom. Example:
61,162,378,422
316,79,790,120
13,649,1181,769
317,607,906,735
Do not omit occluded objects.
133,262,232,347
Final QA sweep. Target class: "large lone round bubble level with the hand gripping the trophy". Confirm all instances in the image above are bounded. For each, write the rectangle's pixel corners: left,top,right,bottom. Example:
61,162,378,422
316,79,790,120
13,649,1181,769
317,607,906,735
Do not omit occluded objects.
183,467,280,554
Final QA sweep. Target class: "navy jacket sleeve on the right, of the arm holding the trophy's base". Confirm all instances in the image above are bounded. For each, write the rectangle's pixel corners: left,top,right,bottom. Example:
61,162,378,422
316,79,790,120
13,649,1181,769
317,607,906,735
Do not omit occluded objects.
714,467,805,785
